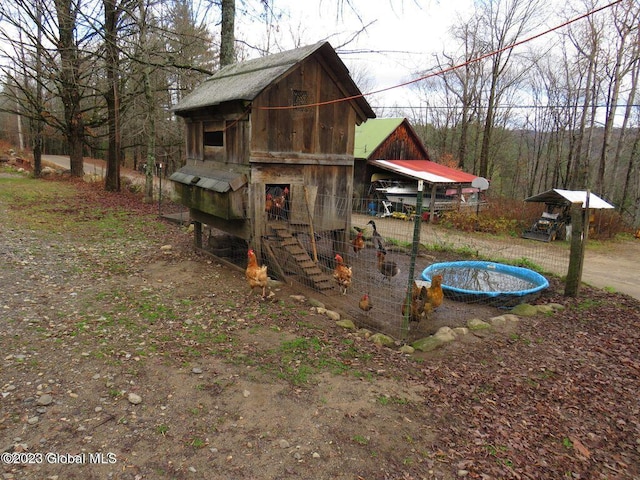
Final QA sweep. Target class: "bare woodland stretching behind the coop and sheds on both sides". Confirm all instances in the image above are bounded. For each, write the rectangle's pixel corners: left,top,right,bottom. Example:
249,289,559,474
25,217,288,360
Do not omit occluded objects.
0,0,640,226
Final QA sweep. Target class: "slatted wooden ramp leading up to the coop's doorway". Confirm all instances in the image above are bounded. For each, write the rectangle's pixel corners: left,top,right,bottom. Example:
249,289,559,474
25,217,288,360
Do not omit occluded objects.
266,223,337,294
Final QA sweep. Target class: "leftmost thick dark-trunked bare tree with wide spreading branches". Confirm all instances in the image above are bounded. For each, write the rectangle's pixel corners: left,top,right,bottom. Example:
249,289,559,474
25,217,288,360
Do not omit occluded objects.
0,0,109,176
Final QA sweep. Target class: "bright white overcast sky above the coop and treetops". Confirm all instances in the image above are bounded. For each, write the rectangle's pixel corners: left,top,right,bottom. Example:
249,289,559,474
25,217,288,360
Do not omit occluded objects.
230,0,611,113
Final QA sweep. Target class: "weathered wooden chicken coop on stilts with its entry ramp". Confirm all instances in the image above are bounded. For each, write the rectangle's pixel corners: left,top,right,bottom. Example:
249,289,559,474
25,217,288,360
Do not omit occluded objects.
170,42,375,288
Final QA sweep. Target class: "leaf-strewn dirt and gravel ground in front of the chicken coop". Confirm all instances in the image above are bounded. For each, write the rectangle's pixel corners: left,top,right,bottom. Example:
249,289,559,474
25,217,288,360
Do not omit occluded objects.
0,173,640,480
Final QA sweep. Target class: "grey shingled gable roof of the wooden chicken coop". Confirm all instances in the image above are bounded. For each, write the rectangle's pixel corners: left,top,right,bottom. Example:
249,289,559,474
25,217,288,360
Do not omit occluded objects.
172,42,375,117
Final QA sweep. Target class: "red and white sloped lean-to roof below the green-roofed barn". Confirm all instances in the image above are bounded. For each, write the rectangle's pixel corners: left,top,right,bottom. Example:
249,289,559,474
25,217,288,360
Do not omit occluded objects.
368,160,477,184
